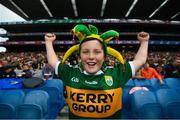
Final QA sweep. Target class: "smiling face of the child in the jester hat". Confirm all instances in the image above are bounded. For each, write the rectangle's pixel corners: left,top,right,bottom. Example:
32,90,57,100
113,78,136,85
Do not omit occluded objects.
80,40,105,74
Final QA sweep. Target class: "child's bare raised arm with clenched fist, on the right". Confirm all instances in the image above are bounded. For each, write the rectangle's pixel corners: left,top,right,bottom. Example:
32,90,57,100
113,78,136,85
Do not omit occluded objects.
132,32,150,71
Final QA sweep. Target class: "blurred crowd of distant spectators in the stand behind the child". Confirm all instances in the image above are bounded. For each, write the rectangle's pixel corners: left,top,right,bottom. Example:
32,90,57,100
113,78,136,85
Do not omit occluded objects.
0,51,180,79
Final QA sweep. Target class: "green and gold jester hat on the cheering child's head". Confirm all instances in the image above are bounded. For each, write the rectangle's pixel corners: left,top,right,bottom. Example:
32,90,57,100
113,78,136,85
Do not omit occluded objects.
62,24,124,64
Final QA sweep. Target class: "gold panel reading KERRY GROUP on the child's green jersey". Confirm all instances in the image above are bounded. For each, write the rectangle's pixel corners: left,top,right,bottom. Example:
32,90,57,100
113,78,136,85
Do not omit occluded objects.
66,86,122,118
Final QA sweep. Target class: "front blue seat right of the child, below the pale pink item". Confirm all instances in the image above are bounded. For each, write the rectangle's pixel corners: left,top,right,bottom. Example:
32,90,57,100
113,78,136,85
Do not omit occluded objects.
131,90,162,119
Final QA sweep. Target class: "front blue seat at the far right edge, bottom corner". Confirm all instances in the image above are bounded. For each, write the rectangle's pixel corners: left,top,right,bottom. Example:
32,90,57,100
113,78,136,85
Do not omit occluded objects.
156,89,180,119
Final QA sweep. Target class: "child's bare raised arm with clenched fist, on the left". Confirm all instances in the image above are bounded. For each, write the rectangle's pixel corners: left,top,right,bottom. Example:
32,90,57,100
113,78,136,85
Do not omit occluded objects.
44,33,58,68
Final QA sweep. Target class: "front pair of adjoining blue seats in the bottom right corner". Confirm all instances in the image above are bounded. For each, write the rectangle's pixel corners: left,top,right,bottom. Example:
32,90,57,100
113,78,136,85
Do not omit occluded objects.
131,89,180,119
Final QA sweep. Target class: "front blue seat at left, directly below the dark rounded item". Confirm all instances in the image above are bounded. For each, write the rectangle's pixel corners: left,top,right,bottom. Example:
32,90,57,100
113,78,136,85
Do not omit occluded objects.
17,90,50,119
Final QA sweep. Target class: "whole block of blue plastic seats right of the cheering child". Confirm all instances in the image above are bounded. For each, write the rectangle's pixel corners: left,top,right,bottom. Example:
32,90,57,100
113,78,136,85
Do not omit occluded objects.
122,78,180,119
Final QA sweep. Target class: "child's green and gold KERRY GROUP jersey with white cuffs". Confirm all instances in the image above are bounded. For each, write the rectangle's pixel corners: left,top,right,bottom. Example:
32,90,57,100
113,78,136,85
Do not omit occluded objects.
56,63,133,119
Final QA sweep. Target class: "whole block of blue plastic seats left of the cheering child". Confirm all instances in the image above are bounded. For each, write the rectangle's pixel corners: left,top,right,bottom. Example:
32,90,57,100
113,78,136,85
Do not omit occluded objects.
0,79,64,119
